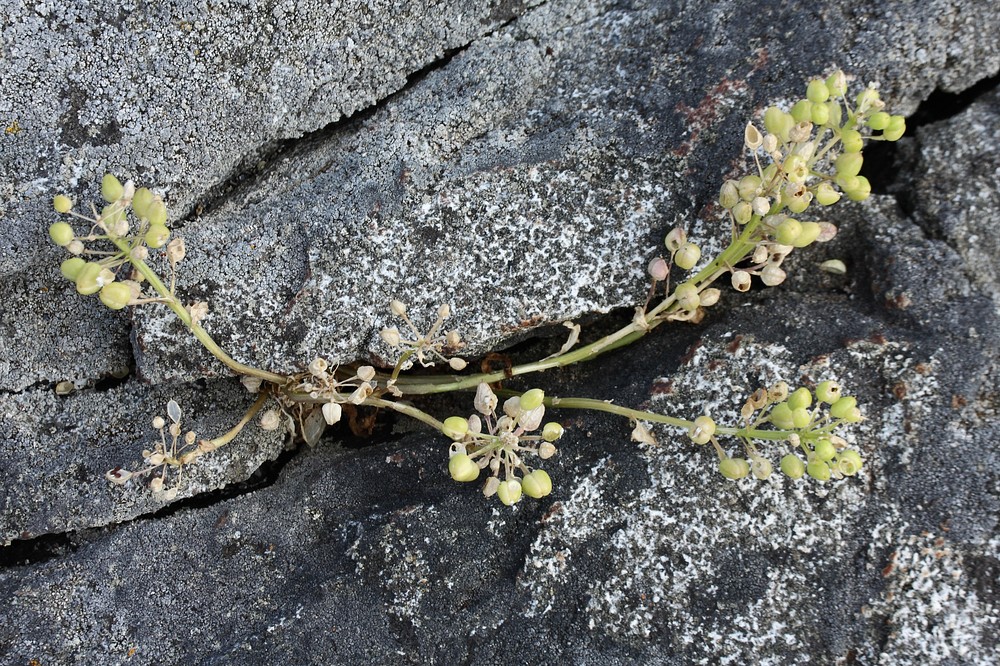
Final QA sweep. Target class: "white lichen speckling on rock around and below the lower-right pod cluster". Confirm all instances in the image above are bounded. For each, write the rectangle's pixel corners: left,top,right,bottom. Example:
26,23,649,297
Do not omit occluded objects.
522,338,976,664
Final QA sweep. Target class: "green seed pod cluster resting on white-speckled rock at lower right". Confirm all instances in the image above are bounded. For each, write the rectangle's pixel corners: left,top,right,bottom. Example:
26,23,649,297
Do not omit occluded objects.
688,381,862,481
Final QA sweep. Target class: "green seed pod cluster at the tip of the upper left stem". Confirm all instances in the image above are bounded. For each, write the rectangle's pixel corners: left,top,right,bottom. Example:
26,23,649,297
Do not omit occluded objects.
49,174,188,316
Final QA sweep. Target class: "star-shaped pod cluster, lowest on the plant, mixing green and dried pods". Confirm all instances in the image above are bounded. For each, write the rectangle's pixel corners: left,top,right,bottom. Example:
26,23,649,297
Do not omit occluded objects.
442,384,563,506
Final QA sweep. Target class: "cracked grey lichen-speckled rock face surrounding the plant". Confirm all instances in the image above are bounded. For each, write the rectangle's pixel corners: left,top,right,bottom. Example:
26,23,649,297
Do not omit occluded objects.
0,2,1000,664
